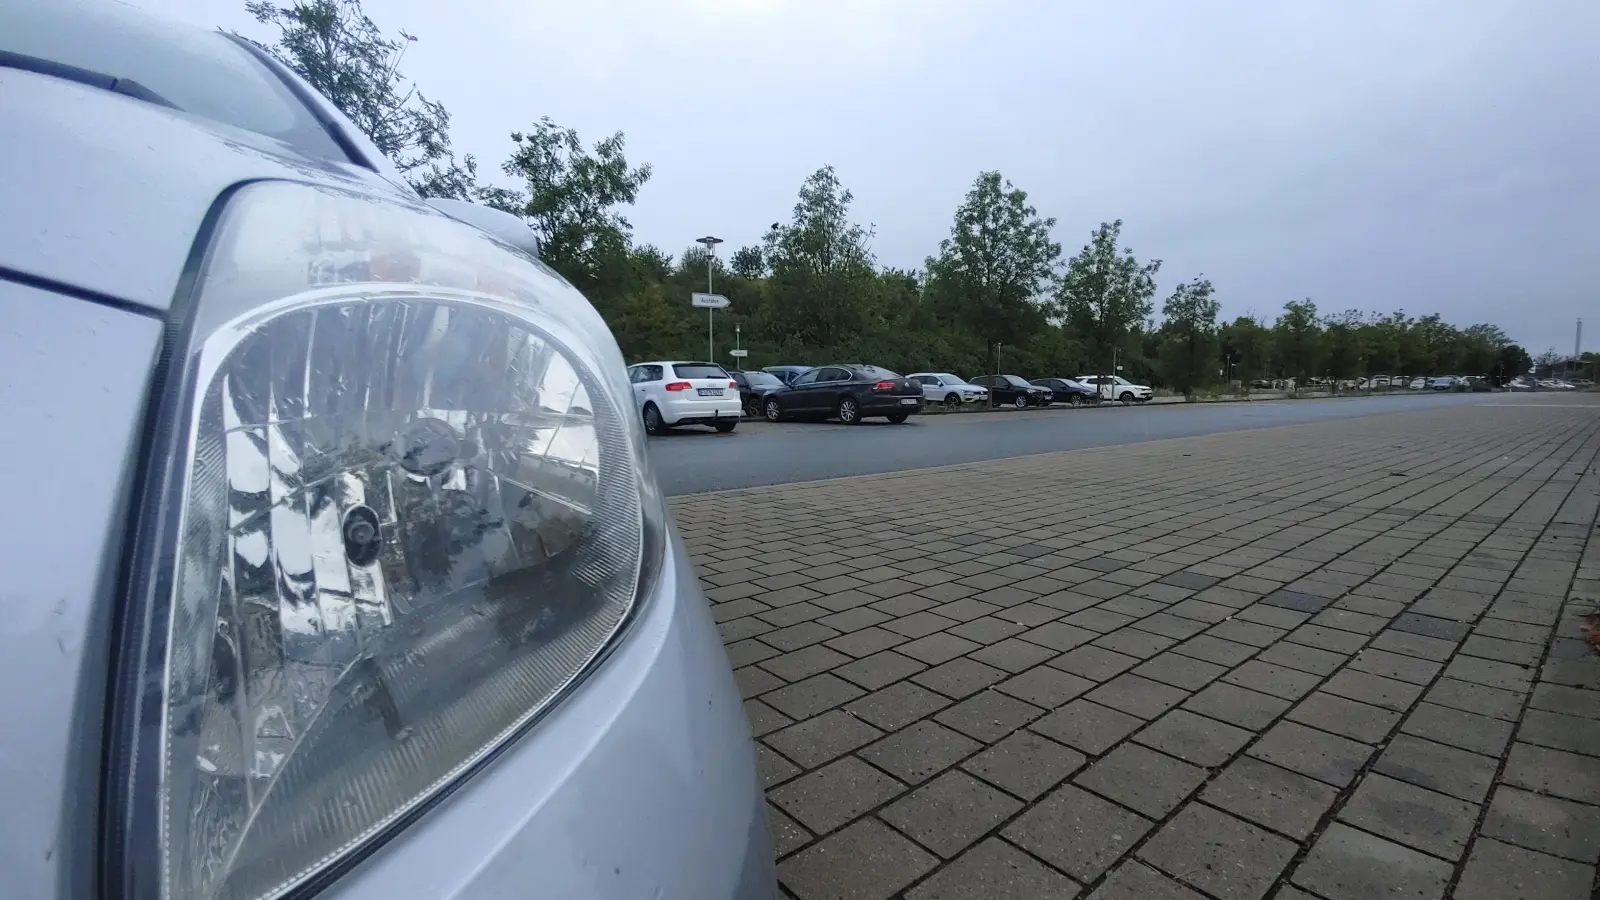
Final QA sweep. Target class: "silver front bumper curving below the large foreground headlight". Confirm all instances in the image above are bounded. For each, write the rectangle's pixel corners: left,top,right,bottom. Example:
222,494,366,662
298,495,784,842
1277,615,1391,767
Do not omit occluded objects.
320,525,778,900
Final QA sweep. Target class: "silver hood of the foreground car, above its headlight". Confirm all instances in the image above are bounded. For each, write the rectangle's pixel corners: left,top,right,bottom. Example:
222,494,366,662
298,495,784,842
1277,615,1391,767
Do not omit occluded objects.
0,69,419,311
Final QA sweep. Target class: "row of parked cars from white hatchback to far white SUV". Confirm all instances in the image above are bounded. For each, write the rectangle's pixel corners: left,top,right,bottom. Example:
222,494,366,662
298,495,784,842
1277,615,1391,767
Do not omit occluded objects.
627,360,1155,434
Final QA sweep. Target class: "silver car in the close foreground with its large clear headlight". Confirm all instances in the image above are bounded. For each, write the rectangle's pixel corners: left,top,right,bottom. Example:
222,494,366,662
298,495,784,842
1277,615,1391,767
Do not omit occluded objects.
0,0,776,900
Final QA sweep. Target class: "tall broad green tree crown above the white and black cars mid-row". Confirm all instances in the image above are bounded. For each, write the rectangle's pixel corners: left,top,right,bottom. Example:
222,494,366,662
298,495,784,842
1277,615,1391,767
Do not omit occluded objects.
928,171,1061,344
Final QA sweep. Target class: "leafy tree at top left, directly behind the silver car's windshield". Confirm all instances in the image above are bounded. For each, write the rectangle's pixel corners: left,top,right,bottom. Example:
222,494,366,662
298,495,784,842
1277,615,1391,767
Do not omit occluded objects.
245,0,460,190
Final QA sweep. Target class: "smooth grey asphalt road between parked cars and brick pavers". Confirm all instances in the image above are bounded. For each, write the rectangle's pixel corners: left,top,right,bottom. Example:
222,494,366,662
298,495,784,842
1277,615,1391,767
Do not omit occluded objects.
650,394,1504,495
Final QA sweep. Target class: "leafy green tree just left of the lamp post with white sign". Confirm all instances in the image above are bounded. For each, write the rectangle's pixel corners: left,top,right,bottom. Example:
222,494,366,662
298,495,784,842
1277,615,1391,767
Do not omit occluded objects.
491,117,650,293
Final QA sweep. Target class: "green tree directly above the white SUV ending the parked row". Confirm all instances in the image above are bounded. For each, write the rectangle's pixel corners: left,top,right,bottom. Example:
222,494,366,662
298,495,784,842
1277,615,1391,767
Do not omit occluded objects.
1054,219,1162,375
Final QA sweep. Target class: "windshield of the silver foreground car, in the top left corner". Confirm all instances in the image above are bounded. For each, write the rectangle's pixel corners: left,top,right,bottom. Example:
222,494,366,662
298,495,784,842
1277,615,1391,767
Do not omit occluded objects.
0,0,349,160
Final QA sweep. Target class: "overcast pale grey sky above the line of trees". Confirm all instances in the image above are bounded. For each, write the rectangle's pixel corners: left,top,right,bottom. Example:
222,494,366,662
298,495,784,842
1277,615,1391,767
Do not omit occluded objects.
136,0,1600,356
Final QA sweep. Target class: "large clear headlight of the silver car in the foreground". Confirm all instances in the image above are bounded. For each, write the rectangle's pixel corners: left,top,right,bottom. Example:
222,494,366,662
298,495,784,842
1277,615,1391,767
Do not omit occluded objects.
107,183,664,900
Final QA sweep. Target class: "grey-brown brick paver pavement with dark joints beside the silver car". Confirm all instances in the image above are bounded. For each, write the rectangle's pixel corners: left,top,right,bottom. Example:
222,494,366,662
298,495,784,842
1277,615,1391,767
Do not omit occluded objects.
672,397,1600,900
